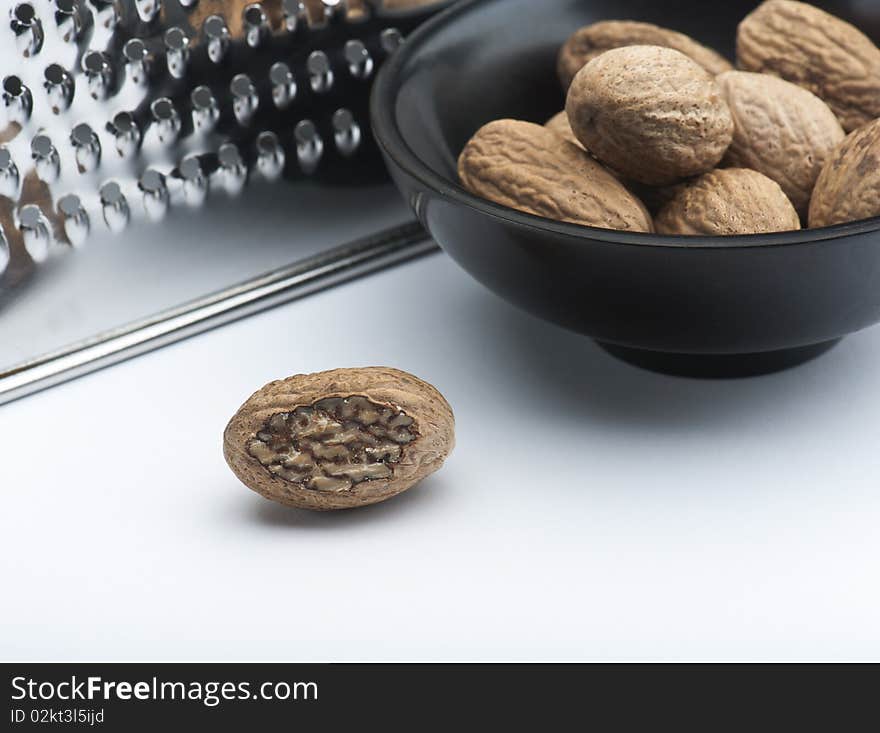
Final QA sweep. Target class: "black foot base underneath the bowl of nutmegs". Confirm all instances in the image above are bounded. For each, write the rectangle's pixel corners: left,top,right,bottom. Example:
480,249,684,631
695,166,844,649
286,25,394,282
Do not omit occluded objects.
598,339,840,379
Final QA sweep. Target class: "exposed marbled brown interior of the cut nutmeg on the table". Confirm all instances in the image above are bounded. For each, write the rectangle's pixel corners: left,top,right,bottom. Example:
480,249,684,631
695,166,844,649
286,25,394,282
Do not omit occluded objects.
247,395,419,492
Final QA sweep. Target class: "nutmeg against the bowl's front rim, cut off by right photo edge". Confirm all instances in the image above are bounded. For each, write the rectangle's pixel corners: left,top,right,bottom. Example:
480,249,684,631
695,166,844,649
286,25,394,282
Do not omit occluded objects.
810,119,880,227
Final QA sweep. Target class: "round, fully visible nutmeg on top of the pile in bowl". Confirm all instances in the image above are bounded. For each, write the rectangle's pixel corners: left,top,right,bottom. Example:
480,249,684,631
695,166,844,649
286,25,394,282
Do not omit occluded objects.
565,46,733,186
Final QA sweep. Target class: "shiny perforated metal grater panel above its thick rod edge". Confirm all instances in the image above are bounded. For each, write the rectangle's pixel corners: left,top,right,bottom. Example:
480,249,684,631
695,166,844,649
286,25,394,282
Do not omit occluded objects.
0,0,448,404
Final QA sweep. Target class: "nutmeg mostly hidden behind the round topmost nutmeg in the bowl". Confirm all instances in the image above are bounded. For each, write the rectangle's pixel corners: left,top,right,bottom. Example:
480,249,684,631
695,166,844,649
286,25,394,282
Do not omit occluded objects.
557,20,733,89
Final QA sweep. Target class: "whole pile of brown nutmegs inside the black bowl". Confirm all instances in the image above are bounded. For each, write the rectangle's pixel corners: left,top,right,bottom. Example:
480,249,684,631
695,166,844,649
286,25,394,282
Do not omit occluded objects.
459,0,880,236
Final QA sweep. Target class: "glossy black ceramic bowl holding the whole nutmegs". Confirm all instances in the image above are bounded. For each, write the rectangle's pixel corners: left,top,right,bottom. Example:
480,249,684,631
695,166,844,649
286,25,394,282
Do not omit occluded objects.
372,0,880,374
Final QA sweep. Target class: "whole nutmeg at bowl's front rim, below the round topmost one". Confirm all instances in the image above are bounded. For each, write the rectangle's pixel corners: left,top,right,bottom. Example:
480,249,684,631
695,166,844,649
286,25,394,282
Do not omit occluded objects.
655,168,801,237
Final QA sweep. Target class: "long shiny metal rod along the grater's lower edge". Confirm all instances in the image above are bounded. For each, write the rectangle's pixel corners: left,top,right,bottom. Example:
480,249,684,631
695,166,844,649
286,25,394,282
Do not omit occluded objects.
0,221,439,404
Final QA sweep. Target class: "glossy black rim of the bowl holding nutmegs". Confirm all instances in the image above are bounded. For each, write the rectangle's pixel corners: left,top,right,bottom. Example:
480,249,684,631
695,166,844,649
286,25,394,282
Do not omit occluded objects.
370,0,880,249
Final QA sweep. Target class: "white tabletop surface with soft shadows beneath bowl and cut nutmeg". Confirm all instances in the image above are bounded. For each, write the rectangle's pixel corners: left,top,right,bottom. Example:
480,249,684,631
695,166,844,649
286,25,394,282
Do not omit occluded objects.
0,249,880,660
